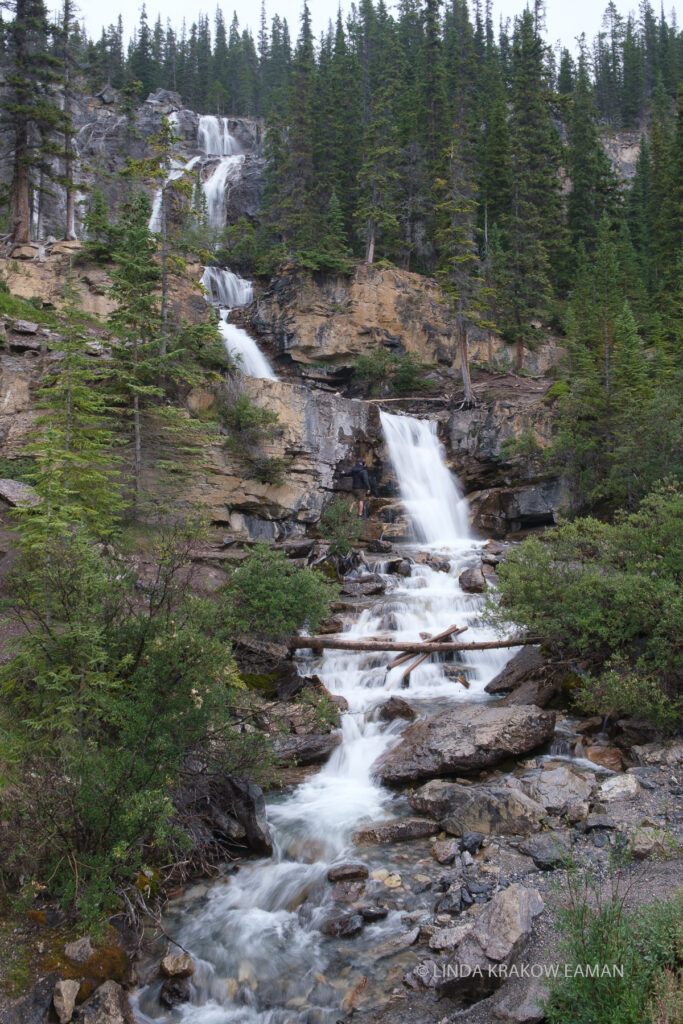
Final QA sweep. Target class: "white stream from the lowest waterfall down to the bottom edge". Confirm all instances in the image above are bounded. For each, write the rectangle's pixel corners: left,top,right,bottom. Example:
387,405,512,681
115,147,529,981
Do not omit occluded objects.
135,414,509,1024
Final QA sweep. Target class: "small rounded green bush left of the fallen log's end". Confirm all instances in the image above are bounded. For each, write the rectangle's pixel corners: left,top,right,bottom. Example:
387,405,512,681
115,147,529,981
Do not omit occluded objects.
224,544,336,638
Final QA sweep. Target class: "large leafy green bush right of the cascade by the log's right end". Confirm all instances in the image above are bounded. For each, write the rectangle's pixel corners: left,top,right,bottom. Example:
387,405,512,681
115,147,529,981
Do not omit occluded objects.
489,482,683,725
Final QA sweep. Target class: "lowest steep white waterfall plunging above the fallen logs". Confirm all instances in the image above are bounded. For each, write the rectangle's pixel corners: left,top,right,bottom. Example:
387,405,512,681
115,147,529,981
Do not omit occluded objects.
380,412,470,552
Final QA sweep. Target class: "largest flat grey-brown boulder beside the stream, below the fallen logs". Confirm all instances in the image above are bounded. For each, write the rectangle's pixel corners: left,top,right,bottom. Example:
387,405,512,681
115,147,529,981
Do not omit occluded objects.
371,705,555,783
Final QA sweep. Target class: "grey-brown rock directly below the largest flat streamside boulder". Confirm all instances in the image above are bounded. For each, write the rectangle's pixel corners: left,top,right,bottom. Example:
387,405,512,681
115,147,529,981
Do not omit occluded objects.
410,779,545,835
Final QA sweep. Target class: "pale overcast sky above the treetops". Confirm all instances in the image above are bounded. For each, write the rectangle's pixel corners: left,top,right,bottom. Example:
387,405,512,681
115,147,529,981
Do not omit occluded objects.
74,0,683,50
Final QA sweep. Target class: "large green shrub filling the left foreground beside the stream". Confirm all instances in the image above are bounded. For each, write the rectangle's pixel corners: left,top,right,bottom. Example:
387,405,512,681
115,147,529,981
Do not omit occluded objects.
0,526,254,926
